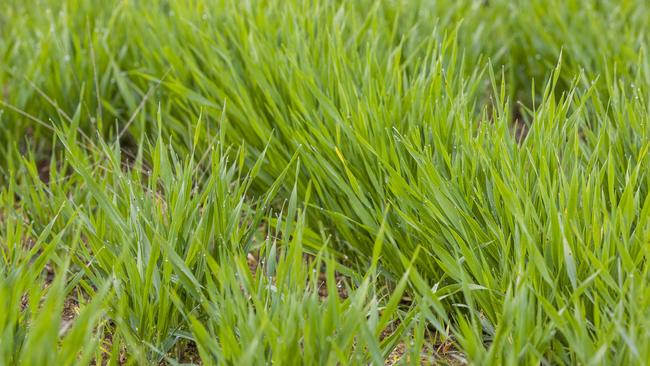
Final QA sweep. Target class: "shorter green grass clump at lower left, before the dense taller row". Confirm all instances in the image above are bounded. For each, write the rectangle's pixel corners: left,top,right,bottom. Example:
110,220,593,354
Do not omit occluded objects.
3,121,430,364
